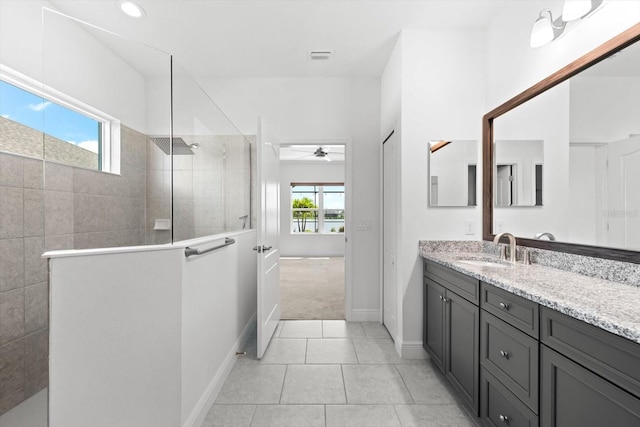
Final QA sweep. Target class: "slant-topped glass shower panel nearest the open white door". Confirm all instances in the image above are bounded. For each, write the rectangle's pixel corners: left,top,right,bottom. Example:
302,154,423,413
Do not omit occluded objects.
173,58,255,241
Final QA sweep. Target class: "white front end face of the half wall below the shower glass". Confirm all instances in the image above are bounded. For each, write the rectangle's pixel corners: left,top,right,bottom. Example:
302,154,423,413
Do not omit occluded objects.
49,248,184,427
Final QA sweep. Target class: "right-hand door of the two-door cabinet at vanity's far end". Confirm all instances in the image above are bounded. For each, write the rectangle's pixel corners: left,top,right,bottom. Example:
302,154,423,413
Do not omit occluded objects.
445,291,480,415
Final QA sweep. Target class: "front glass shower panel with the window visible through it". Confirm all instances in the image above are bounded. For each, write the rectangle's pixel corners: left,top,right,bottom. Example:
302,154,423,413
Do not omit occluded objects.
41,9,171,250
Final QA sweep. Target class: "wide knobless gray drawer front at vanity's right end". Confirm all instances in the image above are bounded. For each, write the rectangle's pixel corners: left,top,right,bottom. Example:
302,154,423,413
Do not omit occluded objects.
540,307,640,397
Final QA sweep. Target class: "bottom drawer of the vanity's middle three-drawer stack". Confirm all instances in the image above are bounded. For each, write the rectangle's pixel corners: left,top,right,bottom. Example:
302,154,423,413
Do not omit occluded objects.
480,369,538,427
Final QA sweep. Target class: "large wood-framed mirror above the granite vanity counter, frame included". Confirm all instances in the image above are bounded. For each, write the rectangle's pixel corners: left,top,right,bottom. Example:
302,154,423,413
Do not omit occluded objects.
482,24,640,264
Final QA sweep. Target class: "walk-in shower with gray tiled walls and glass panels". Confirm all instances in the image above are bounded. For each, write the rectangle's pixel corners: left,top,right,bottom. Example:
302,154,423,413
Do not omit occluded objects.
0,6,255,416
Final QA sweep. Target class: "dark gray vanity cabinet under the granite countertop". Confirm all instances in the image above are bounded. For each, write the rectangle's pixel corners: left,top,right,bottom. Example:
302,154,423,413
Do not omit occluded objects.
424,261,640,427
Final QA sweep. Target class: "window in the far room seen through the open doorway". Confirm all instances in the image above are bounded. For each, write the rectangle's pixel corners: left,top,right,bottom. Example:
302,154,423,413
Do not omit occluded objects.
291,183,345,234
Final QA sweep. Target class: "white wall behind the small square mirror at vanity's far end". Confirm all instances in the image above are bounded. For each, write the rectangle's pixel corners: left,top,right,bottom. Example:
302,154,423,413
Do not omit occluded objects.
392,30,484,348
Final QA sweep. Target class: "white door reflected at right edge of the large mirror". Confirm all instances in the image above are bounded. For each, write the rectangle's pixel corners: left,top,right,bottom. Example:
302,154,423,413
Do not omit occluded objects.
606,136,640,250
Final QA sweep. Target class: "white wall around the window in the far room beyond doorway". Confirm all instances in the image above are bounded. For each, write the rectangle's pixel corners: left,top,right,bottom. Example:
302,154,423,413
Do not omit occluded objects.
280,161,349,256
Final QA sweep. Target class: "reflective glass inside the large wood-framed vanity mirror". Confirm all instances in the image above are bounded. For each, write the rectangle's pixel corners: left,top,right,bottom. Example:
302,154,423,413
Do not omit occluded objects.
493,43,640,250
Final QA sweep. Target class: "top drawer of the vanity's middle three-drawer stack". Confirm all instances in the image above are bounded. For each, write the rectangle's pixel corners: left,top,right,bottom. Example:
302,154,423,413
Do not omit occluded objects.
480,282,540,338
